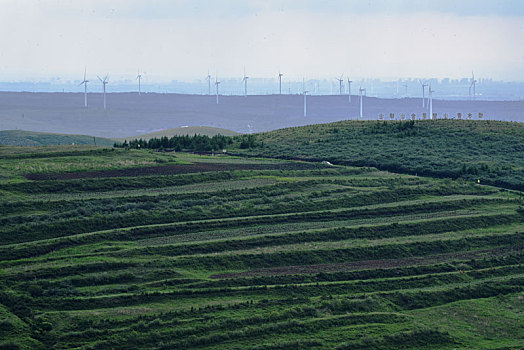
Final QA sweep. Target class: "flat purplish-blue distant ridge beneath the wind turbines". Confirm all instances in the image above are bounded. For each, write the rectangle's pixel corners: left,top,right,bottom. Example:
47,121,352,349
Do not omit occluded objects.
0,91,524,138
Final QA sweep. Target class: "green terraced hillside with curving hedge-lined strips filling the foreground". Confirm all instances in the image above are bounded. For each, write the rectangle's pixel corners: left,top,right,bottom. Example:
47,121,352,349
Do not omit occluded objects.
0,147,524,349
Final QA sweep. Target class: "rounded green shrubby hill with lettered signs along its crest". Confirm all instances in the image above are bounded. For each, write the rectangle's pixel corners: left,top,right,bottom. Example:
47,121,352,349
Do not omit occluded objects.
233,120,524,190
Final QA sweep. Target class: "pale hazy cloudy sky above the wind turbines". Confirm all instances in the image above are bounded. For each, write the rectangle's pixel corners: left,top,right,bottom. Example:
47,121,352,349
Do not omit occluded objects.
0,0,524,81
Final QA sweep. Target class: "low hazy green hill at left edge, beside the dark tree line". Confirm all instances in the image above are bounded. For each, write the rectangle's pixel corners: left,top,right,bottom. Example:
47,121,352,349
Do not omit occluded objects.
0,130,114,146
